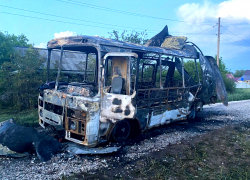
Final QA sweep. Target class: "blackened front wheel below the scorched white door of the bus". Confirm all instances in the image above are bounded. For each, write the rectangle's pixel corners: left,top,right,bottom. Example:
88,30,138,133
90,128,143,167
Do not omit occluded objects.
112,120,131,141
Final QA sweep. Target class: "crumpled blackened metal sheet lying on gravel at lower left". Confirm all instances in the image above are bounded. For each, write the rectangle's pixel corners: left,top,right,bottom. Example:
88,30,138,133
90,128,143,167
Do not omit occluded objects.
0,120,62,161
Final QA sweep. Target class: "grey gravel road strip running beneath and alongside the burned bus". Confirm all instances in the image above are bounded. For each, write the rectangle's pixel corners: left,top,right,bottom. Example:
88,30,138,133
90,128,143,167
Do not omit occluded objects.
0,100,250,180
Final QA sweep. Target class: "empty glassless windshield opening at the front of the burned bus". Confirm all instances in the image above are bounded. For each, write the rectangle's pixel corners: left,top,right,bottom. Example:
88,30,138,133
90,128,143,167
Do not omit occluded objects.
46,46,98,85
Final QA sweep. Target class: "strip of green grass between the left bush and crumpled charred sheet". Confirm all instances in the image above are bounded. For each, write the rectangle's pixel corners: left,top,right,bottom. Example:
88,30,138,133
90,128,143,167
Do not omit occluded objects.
0,108,39,127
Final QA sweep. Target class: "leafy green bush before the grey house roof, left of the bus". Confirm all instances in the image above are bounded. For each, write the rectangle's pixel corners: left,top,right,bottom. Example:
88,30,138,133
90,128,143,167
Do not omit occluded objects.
0,48,45,110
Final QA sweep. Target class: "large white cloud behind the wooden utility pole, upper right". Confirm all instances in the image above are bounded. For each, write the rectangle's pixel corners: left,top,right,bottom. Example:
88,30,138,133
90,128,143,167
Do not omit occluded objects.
175,0,250,70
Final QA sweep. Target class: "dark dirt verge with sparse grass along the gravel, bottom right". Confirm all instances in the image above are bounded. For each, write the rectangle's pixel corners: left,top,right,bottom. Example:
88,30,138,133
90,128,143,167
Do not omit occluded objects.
63,123,250,180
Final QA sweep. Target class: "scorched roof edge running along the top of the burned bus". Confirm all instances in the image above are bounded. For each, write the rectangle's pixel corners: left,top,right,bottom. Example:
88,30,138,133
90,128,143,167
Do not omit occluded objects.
47,35,199,59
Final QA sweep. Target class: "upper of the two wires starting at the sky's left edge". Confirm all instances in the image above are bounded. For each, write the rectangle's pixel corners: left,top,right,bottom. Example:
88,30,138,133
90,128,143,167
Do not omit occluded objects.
0,5,157,32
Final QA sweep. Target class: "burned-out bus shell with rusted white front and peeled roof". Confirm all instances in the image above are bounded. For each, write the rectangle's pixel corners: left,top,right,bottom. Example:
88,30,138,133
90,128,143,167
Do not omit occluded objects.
38,25,227,147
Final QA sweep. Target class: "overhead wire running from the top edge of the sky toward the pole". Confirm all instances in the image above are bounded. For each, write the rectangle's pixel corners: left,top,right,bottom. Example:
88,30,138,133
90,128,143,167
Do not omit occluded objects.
54,0,213,24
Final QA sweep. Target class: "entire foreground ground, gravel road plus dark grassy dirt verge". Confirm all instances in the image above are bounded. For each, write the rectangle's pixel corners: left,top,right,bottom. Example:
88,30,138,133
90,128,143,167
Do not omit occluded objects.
0,100,250,180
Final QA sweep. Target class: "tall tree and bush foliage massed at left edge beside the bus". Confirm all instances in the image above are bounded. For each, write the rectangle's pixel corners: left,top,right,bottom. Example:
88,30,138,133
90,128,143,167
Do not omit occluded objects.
0,34,45,110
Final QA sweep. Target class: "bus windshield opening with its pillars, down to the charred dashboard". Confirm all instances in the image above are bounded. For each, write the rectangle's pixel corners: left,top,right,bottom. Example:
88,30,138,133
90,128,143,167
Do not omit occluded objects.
47,47,98,94
